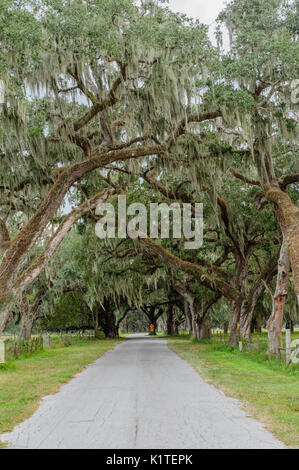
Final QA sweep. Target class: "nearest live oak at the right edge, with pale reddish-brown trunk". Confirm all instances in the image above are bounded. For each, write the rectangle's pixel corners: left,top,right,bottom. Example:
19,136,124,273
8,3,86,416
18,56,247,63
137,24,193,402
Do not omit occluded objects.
216,0,299,352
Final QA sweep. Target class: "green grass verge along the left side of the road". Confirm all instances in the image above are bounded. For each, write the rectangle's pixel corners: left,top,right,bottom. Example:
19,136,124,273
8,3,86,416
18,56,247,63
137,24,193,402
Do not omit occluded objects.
0,339,121,447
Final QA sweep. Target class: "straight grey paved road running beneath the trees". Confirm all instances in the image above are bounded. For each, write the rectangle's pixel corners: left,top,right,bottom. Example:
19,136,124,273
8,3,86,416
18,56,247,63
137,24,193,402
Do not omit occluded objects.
0,335,284,449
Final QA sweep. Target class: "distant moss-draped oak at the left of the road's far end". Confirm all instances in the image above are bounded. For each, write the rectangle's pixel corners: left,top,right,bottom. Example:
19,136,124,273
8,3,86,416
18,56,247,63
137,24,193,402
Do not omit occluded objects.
46,219,173,338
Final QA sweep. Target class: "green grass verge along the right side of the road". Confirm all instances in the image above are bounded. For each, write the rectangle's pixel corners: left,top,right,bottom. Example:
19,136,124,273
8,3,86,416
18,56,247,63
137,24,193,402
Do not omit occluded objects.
168,334,299,448
